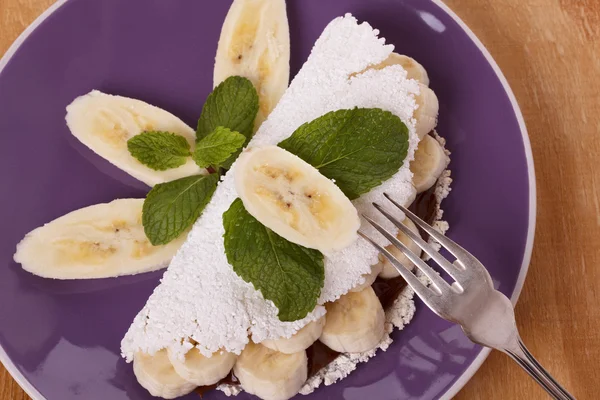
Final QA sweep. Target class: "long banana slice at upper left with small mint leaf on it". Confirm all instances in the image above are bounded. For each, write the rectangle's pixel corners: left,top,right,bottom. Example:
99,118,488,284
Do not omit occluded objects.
66,90,204,186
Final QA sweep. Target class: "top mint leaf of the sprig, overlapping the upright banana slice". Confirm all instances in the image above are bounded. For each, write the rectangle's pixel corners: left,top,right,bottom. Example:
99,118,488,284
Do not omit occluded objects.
196,76,258,141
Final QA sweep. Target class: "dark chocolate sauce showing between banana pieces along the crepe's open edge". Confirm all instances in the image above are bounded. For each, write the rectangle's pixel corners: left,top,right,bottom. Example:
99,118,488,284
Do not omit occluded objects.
196,185,438,397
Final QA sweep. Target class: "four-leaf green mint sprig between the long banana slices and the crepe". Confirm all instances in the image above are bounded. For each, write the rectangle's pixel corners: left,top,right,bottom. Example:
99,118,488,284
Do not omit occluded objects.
127,76,258,245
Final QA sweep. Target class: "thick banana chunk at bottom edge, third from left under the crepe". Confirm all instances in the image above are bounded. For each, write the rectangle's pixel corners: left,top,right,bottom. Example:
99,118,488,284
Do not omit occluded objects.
233,342,308,400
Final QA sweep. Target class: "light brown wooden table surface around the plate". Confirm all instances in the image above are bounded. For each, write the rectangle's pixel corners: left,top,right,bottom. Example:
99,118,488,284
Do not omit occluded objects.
0,0,600,400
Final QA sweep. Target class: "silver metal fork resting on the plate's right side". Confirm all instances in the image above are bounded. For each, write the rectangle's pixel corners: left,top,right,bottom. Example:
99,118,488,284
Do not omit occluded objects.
359,193,575,400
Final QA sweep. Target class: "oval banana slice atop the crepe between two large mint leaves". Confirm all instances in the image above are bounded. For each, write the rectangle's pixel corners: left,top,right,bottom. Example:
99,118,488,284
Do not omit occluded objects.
234,146,360,253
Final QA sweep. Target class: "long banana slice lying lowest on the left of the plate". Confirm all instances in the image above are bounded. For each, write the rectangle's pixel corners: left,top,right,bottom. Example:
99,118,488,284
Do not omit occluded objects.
14,199,186,279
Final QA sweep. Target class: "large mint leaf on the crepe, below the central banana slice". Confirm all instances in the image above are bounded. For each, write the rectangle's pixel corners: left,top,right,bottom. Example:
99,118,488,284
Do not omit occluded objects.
223,199,325,321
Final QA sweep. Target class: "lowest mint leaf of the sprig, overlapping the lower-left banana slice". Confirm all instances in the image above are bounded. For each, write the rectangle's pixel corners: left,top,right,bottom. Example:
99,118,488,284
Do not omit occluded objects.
142,174,219,246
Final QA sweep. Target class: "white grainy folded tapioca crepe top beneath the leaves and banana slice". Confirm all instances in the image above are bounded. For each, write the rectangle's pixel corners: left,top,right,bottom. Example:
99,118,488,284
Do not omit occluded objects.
121,15,419,360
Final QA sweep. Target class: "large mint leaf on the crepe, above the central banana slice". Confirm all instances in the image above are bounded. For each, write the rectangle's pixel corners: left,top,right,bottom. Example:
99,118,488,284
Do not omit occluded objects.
279,108,408,200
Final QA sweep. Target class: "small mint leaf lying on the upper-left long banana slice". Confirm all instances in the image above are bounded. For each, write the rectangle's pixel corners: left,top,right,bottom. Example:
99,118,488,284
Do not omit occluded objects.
127,131,190,171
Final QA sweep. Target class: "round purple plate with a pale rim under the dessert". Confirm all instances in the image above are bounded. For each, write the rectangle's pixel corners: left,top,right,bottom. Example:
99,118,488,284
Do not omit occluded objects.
0,0,535,400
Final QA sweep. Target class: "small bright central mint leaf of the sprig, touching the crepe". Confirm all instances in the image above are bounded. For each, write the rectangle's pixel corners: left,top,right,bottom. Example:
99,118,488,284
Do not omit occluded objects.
193,126,246,168
